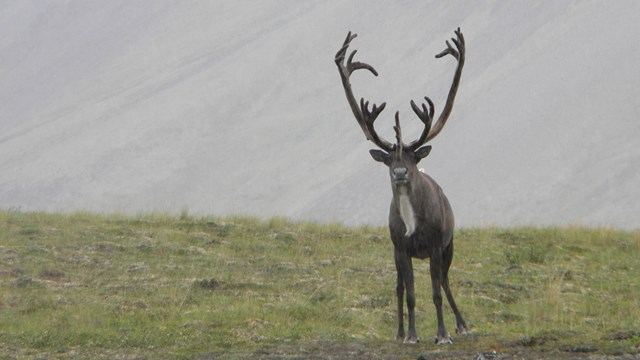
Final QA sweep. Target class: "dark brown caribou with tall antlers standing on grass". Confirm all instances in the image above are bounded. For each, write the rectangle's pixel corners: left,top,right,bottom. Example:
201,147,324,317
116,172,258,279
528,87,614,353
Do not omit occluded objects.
335,28,468,344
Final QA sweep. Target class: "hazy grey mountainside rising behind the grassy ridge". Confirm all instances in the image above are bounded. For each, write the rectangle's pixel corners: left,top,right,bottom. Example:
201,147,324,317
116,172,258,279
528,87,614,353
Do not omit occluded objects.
0,0,640,228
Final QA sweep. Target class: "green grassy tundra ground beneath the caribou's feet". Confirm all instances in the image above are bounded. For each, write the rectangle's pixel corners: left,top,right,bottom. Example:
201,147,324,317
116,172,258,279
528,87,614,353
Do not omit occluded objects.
0,212,640,359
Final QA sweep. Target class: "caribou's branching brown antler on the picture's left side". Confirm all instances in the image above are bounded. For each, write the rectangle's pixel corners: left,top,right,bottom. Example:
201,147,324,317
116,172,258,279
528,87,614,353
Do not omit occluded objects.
335,31,393,152
